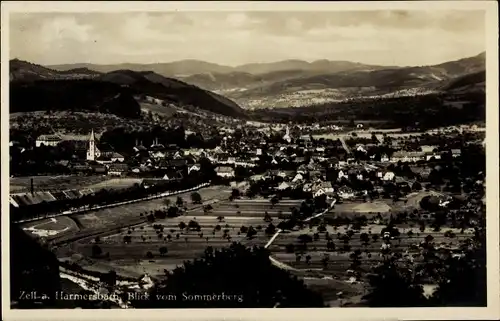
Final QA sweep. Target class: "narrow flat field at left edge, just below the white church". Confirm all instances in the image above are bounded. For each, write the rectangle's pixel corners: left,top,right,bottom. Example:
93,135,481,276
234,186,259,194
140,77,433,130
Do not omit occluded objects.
10,175,109,193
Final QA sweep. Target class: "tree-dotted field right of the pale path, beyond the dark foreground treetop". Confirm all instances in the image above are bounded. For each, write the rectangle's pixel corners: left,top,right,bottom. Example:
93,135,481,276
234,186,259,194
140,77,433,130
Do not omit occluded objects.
269,225,473,307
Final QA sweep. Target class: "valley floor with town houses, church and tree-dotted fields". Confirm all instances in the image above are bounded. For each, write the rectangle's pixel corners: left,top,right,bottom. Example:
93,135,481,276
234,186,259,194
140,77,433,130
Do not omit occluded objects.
10,102,485,306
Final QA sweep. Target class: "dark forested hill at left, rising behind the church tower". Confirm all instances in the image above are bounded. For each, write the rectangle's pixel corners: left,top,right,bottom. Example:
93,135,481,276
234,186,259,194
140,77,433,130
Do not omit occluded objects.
10,60,245,118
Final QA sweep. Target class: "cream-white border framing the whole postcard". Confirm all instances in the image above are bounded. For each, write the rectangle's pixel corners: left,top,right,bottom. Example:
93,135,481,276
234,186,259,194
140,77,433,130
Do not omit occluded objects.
1,1,500,321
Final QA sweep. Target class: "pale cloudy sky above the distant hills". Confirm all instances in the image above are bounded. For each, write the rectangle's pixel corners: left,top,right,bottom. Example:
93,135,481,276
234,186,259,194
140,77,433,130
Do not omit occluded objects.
9,10,486,66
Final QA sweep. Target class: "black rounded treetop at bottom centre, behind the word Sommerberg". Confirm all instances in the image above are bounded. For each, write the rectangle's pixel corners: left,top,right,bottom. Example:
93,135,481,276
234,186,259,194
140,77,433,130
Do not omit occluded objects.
131,243,324,308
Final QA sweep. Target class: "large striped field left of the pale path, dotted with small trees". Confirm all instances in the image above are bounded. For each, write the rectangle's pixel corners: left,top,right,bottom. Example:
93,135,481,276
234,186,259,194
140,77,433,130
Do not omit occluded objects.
65,198,300,277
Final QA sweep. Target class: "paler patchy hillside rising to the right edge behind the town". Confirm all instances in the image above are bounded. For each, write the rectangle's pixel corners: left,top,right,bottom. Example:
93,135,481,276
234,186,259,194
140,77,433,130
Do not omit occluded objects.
226,54,485,109
